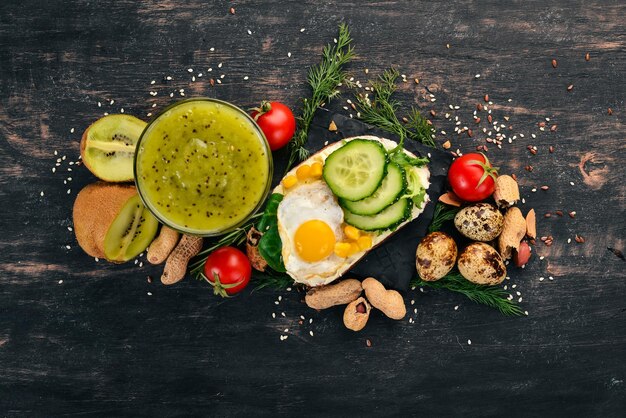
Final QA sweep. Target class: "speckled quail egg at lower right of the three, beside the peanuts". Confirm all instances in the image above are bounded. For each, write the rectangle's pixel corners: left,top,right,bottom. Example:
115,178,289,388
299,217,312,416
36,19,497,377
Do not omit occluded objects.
457,242,506,285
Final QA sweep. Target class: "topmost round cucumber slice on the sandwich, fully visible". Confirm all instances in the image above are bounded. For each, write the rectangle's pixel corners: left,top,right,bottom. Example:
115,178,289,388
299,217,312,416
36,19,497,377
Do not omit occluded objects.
323,139,387,200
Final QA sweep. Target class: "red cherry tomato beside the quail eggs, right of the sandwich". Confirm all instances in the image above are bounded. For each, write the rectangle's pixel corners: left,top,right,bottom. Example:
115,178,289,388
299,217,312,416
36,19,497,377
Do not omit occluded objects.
448,152,498,202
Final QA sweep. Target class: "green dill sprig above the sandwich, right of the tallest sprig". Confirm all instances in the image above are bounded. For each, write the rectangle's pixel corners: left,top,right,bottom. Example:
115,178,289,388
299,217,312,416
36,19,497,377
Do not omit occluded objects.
355,68,435,148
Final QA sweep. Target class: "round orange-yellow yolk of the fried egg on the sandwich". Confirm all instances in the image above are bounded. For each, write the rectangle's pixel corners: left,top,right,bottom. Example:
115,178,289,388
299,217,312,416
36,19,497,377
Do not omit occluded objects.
294,219,335,262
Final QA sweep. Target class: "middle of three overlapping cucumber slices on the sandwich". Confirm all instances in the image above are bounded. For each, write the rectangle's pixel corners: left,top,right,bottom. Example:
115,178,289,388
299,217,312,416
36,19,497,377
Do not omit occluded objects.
339,163,407,215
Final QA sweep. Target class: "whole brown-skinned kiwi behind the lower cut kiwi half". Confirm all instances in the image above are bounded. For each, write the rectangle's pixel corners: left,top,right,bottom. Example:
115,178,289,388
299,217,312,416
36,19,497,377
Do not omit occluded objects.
73,181,137,258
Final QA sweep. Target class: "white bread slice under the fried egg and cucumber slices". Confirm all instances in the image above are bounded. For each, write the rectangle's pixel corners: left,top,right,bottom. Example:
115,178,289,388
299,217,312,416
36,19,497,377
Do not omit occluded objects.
273,135,430,286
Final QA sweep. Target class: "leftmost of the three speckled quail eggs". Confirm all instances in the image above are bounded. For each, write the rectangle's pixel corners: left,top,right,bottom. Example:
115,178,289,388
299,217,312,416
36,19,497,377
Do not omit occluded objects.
415,232,457,282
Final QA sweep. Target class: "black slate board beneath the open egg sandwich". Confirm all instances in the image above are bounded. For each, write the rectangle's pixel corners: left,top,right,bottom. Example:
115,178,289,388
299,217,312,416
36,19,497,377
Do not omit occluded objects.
275,109,452,291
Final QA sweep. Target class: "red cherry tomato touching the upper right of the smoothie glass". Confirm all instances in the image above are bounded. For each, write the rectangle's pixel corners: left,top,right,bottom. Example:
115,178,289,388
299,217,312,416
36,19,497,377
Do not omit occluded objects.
251,102,296,151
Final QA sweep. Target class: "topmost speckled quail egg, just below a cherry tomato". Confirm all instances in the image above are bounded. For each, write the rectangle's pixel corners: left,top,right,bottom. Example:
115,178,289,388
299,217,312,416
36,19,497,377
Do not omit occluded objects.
454,203,504,242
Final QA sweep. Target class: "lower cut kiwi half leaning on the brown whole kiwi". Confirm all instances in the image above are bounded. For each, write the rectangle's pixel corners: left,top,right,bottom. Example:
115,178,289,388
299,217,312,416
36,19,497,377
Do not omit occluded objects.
104,195,159,262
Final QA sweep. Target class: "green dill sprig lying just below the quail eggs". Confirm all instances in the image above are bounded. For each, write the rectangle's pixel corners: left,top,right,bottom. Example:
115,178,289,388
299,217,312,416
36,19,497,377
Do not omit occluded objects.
411,272,524,316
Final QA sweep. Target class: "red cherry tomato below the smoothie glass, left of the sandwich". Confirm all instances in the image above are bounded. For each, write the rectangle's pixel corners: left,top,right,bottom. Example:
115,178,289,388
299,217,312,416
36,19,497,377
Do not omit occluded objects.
204,247,252,297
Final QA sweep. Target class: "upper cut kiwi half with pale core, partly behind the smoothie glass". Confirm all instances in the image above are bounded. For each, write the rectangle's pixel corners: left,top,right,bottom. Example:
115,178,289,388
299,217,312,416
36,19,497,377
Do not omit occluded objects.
80,115,147,182
